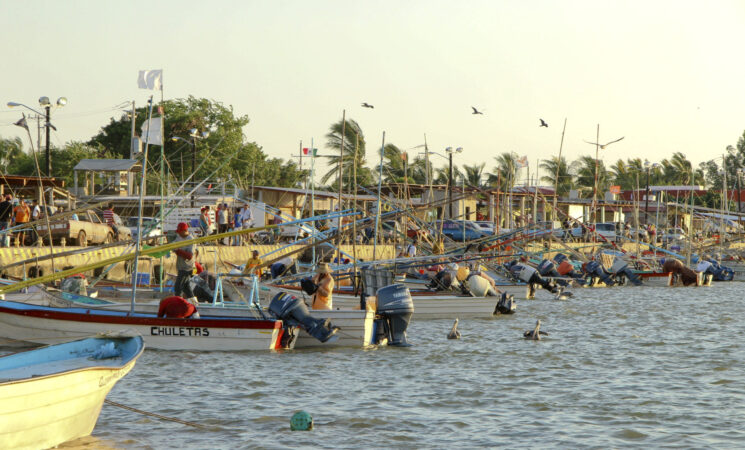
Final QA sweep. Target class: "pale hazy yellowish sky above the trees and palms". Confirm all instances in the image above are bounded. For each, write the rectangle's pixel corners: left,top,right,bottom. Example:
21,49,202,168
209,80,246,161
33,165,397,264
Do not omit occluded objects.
0,0,745,185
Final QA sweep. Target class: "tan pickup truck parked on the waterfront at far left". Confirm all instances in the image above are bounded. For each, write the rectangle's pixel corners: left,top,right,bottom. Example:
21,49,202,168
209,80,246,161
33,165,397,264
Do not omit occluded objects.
37,210,132,247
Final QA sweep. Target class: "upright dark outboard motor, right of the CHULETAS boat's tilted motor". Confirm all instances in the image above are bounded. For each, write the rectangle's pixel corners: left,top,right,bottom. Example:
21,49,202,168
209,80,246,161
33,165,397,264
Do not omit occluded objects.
375,284,414,347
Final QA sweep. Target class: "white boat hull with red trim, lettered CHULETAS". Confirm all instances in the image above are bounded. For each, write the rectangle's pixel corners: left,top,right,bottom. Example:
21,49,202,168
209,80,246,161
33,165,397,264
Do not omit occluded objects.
0,301,297,351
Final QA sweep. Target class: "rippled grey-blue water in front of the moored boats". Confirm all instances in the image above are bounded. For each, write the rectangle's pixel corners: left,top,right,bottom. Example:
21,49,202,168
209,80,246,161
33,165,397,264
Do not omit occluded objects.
26,283,745,449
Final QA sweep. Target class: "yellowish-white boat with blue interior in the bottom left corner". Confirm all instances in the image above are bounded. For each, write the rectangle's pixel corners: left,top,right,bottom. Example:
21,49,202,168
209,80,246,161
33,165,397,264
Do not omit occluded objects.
0,336,144,449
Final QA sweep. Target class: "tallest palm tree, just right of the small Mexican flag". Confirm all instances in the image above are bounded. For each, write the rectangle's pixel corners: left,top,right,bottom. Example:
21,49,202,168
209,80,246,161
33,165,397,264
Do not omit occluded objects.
321,119,373,189
